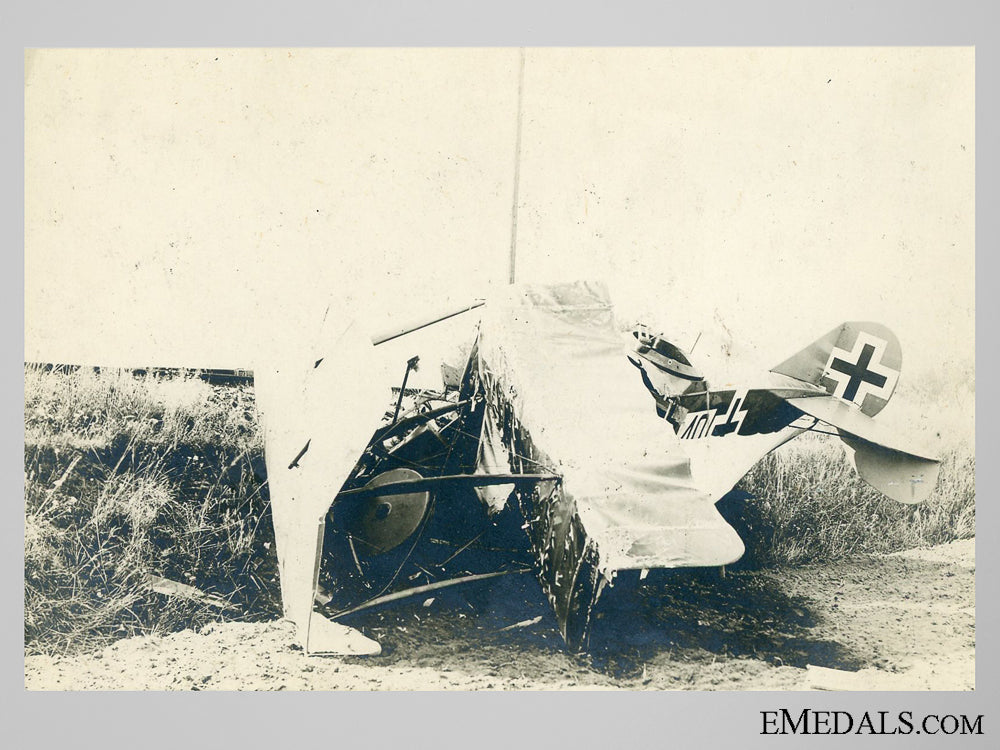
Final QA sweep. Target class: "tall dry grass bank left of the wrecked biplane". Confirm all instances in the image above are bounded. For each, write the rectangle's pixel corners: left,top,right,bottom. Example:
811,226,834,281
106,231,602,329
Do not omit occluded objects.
24,366,280,653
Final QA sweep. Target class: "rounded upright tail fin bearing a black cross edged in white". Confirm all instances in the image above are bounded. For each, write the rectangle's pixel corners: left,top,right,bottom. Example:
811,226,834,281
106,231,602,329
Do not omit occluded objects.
771,322,903,417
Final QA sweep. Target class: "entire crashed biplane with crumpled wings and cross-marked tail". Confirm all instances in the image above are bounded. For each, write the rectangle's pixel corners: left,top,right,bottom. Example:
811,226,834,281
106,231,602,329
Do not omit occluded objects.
254,282,938,654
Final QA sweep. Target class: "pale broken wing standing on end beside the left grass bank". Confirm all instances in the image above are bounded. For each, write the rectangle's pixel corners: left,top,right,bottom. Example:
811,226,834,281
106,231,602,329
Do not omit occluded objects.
254,314,391,654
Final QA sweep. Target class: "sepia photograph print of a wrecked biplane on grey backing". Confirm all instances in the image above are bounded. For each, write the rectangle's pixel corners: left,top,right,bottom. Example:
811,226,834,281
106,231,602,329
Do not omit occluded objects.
24,47,976,691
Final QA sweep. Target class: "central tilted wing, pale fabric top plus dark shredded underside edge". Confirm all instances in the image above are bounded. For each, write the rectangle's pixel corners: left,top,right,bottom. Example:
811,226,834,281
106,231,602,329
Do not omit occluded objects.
463,282,744,645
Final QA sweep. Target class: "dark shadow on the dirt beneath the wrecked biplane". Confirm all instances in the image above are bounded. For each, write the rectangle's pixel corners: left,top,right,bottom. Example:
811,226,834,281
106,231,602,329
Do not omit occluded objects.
334,569,865,680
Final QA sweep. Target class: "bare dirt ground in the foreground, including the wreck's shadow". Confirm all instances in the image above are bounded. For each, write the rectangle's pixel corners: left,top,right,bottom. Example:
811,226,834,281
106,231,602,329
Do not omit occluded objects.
25,540,975,690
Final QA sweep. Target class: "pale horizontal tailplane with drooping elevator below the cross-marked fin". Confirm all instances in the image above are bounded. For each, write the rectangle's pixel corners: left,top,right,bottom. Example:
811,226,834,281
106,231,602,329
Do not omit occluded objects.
788,396,940,504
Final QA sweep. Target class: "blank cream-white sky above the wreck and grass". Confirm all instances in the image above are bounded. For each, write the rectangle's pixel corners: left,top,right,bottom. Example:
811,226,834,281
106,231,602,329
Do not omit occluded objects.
25,48,975,388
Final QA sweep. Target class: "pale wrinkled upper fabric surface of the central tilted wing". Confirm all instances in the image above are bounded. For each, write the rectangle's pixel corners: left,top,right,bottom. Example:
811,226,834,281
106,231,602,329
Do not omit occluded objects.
479,282,744,570
